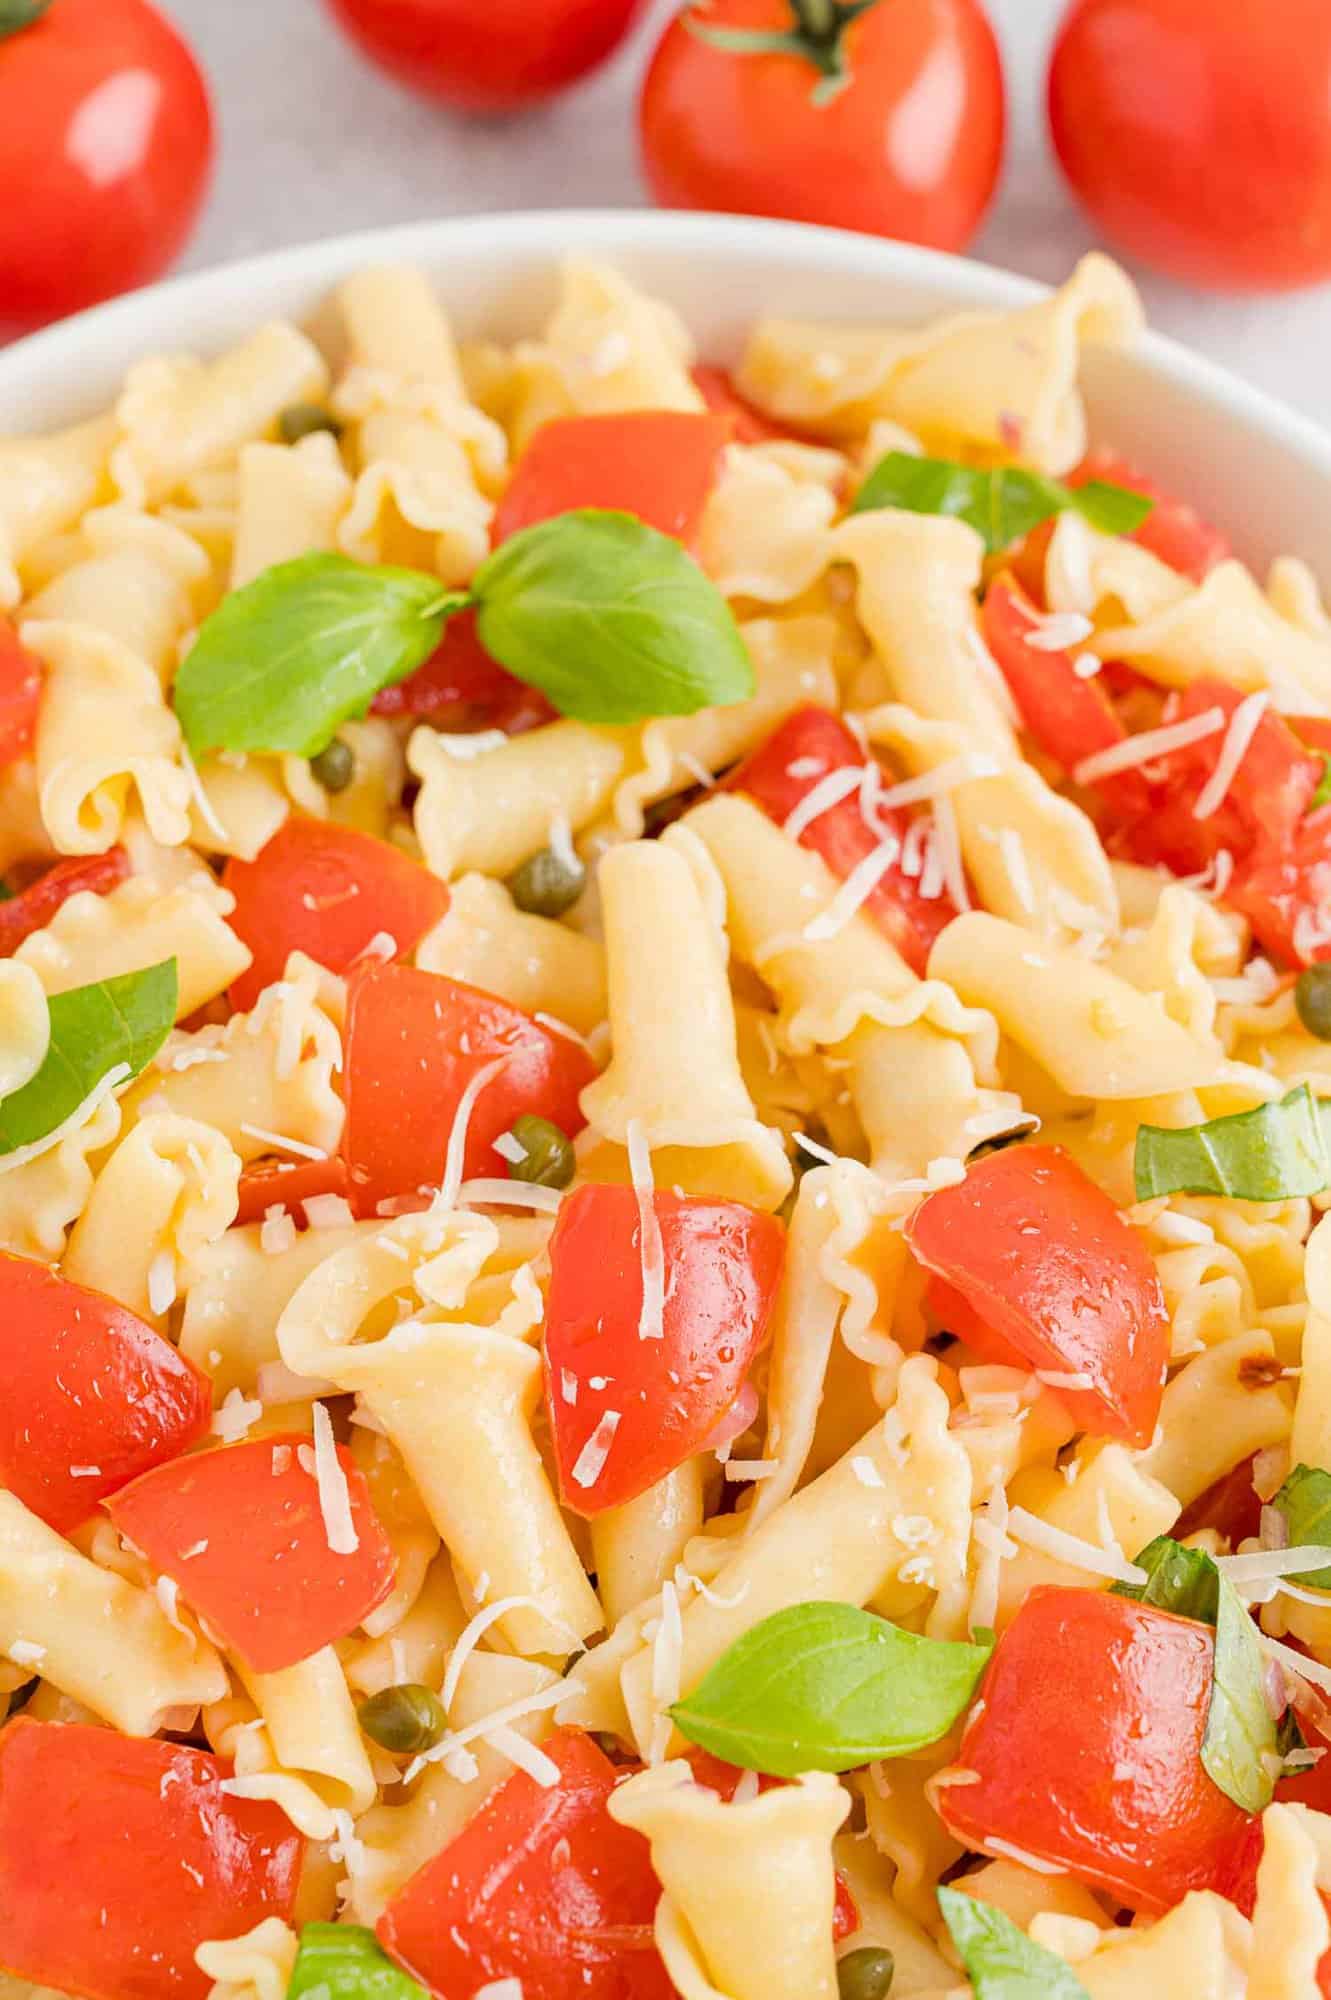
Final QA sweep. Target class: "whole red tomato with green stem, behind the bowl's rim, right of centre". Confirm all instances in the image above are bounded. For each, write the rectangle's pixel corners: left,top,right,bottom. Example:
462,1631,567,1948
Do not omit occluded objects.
640,0,1003,250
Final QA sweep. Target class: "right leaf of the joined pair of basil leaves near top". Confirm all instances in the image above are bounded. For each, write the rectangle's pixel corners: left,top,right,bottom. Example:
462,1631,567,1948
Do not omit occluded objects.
472,508,753,724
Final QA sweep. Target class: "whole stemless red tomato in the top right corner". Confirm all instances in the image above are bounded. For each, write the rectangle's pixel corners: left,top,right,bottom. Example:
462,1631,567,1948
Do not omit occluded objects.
1049,0,1331,292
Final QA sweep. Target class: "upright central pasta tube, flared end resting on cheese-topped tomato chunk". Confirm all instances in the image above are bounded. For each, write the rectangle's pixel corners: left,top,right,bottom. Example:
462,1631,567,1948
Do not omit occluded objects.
580,832,791,1208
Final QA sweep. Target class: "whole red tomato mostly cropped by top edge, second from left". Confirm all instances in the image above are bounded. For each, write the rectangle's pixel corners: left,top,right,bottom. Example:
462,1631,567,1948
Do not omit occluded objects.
319,0,644,112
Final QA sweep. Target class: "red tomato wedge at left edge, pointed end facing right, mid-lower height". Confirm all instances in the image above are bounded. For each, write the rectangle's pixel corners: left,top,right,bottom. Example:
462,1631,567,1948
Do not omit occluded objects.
0,1254,212,1536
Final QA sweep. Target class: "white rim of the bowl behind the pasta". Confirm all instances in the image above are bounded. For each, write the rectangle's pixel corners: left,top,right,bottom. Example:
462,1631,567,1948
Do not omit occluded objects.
0,208,1331,468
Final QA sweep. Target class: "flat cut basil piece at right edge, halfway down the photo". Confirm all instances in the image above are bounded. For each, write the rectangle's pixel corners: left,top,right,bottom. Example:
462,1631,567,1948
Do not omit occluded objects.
1133,1084,1331,1202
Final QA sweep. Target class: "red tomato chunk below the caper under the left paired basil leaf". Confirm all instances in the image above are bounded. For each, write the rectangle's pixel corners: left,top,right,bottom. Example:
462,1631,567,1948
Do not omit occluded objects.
222,816,448,1010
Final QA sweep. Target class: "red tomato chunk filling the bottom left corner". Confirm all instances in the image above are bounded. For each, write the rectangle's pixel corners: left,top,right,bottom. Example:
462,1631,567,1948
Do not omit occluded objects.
0,1716,306,2000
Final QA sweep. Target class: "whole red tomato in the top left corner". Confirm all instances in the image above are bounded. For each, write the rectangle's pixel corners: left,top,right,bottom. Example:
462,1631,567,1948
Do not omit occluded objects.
0,0,212,330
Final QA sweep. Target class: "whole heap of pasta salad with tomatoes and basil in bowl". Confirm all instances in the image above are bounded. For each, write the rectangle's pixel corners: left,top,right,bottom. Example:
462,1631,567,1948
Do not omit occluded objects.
0,256,1331,2000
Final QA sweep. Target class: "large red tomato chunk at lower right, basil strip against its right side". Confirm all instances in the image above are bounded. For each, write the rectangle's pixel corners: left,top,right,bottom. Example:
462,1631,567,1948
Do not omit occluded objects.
937,1586,1253,1916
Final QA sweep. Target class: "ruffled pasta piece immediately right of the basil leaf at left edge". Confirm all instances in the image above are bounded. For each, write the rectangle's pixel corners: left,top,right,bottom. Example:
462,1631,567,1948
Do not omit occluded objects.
125,956,346,1166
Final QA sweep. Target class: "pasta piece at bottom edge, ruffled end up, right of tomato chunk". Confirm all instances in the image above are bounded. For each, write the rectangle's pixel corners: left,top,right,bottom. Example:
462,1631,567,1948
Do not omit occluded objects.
608,1762,849,2000
